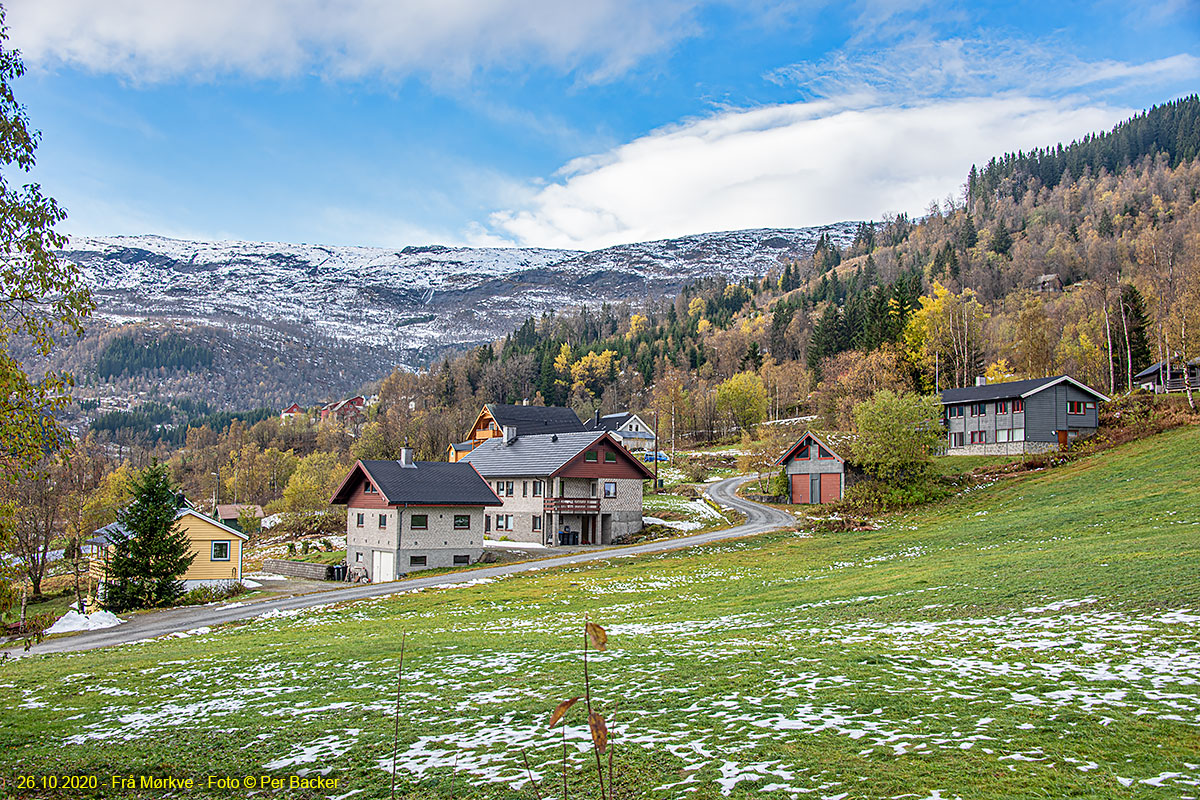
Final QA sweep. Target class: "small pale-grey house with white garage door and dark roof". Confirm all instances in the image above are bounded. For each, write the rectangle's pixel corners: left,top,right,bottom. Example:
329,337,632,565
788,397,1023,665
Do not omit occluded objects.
330,447,500,583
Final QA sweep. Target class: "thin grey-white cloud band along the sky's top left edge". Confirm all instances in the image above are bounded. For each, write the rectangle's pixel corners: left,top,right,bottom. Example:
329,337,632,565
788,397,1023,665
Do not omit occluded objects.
5,0,696,82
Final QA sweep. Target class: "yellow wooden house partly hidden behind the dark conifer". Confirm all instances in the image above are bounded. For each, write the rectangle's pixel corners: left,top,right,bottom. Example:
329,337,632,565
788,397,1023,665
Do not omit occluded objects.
86,507,250,591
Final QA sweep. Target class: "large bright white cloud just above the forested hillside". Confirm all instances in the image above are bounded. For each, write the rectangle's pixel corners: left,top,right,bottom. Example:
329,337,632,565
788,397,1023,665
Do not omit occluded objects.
491,96,1130,248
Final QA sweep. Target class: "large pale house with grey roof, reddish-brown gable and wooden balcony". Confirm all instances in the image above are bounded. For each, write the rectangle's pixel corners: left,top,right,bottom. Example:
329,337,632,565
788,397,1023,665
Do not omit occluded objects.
460,427,653,546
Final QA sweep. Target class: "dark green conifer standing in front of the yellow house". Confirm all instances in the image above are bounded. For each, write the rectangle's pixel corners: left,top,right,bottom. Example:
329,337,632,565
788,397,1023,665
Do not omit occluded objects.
104,462,196,610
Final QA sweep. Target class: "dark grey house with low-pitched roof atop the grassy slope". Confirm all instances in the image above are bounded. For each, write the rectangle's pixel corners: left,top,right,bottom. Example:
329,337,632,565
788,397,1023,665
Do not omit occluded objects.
941,375,1109,456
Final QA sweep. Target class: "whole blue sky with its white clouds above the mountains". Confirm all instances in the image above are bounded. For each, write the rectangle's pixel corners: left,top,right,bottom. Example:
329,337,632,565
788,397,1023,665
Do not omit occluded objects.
5,0,1200,248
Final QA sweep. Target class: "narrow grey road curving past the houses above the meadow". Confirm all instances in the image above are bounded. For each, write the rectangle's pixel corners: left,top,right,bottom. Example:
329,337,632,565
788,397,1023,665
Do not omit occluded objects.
6,475,796,657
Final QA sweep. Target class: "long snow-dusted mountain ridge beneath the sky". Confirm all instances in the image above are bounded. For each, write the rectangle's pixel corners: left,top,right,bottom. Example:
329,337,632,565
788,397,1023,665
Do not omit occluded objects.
62,222,858,366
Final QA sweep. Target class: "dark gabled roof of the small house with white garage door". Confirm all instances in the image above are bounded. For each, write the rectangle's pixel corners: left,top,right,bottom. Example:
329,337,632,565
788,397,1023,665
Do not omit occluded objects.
330,461,500,506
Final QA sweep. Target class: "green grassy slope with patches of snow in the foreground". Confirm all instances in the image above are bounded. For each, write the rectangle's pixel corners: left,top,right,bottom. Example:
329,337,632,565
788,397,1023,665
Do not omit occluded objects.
0,428,1200,798
